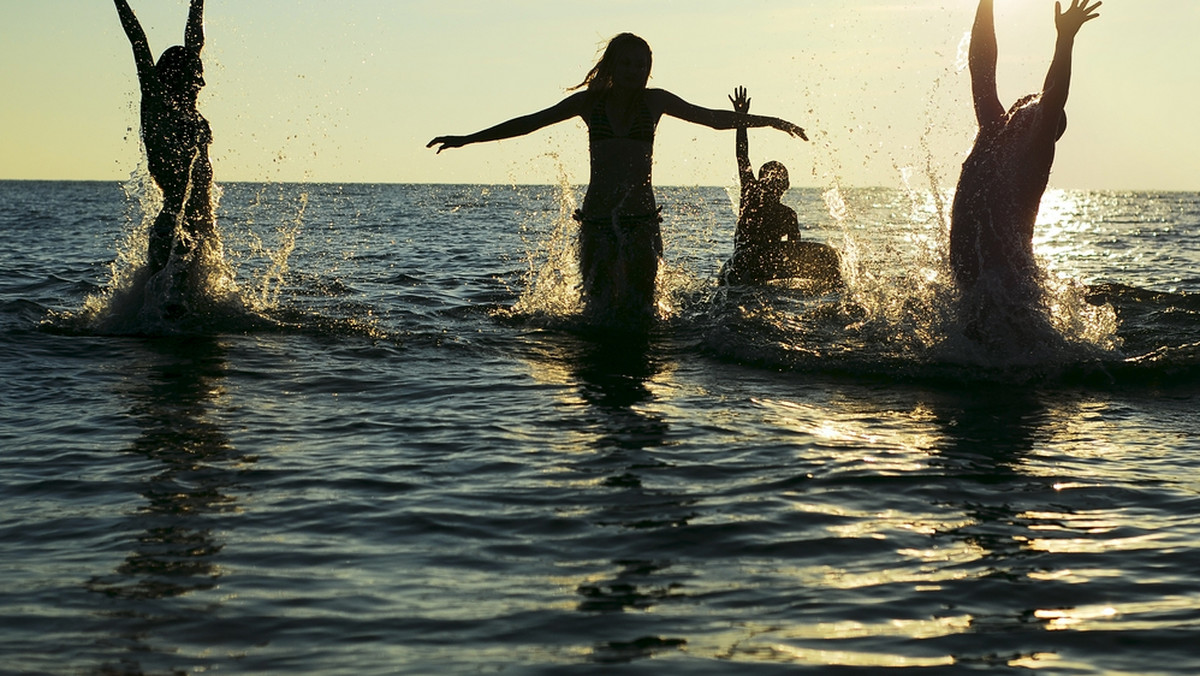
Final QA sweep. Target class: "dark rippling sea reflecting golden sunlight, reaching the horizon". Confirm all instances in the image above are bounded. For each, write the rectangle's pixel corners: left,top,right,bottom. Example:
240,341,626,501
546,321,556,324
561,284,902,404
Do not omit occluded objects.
0,181,1200,675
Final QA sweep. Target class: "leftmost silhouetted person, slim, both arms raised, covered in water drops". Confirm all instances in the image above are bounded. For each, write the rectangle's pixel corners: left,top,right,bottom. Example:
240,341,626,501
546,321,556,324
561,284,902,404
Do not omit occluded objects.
114,0,216,288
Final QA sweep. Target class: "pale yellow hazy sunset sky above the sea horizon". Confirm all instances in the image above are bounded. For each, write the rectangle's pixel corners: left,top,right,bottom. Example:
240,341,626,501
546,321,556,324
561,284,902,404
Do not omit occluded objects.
0,0,1200,190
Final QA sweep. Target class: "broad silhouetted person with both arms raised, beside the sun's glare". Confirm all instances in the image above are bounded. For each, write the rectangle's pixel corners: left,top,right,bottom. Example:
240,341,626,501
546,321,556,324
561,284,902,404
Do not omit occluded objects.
950,0,1100,297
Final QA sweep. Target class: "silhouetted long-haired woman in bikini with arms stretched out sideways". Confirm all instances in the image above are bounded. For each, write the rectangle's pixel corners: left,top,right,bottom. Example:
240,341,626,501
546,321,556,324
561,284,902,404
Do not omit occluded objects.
427,32,808,322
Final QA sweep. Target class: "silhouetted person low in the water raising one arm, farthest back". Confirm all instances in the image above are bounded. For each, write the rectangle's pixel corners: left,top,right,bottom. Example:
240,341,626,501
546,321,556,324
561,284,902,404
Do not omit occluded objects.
721,86,841,289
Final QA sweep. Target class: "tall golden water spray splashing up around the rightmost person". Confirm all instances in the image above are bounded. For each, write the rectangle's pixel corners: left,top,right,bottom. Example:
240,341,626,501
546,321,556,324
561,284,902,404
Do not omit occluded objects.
796,32,1120,379
